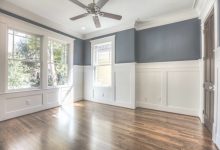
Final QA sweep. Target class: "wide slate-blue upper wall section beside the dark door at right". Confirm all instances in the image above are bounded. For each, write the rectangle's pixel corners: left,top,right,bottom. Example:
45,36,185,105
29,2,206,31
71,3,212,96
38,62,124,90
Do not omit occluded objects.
136,19,201,63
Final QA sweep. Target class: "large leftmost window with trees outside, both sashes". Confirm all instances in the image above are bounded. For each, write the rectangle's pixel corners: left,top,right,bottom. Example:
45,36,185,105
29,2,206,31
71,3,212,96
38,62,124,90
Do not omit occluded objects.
8,29,41,90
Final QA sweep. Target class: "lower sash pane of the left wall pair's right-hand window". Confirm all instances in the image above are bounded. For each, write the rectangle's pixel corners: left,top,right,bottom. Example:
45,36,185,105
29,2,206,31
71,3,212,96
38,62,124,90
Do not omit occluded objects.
48,63,68,86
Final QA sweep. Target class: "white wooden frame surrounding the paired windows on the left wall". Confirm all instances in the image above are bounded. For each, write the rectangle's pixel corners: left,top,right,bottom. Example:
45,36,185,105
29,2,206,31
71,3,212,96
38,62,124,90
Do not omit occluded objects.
0,14,75,94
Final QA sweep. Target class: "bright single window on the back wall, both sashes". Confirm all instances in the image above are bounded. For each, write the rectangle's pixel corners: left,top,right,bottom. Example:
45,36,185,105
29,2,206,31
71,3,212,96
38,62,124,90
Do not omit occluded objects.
93,42,112,87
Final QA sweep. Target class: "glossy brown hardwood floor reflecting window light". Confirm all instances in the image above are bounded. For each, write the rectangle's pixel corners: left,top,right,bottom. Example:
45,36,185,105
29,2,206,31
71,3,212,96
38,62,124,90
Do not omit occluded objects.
0,101,216,150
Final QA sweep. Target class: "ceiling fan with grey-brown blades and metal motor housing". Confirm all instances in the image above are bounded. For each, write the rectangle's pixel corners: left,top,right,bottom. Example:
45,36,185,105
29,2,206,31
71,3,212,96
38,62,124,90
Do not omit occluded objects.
70,0,122,28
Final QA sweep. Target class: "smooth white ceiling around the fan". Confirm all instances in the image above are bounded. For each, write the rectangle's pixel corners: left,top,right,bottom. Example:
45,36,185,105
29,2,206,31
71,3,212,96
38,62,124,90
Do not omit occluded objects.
5,0,194,34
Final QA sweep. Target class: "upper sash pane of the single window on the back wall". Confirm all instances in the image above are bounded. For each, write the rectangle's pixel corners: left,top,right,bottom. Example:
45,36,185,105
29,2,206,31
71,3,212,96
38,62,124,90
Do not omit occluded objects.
94,42,112,65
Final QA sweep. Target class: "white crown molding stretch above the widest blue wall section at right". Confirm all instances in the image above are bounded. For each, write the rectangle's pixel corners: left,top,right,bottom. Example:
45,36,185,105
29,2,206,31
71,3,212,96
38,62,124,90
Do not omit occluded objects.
135,9,199,30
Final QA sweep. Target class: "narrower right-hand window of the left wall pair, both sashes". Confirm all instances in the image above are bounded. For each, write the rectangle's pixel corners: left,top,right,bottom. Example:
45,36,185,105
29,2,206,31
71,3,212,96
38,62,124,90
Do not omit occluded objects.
48,39,68,86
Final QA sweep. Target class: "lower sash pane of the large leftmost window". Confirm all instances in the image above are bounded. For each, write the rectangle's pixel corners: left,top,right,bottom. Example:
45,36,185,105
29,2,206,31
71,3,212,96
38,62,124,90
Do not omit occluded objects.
8,60,40,89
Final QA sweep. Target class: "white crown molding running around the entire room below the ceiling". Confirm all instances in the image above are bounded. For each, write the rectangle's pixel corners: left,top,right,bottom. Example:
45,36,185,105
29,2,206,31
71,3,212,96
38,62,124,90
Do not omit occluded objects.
0,0,203,40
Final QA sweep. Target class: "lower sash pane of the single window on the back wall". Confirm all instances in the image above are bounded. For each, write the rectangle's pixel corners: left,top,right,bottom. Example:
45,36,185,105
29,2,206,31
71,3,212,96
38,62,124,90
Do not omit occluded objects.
95,66,112,86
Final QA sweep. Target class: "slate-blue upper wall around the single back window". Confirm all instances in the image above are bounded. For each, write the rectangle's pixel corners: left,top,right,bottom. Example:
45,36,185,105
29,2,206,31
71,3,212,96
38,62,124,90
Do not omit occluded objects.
84,29,135,65
